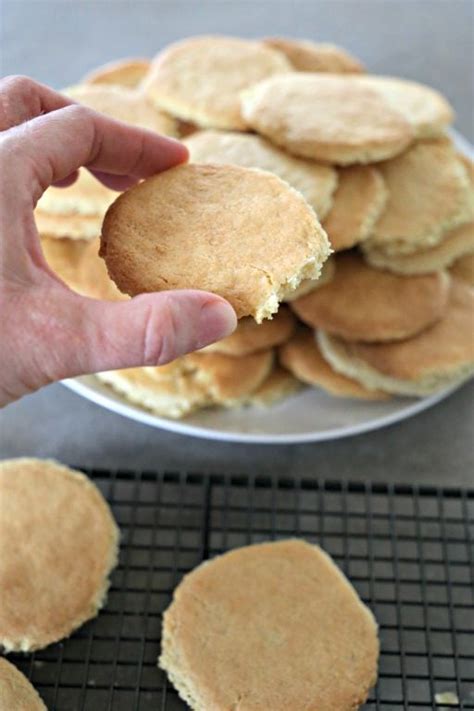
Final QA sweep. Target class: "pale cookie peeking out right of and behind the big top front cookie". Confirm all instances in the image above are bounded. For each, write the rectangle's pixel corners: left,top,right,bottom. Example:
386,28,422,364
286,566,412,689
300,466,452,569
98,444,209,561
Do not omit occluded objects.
357,74,454,138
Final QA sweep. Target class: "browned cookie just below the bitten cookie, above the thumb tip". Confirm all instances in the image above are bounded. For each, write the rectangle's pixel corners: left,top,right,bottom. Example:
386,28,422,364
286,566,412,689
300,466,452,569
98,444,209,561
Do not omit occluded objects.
200,307,296,357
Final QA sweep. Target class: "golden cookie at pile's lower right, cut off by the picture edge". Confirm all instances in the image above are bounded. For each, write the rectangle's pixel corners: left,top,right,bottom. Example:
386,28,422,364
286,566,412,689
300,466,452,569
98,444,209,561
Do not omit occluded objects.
318,280,474,397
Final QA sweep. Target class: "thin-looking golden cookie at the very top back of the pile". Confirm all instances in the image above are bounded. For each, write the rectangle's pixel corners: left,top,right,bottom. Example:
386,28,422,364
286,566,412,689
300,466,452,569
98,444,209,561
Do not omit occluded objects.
263,37,365,74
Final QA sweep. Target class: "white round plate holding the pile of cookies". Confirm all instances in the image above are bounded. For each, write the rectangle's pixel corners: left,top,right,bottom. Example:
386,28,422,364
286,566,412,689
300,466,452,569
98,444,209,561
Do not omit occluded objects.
63,131,474,444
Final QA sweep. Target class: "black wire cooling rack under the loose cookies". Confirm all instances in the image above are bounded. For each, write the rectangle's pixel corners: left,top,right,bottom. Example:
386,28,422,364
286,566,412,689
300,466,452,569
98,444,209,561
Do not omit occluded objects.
10,471,474,711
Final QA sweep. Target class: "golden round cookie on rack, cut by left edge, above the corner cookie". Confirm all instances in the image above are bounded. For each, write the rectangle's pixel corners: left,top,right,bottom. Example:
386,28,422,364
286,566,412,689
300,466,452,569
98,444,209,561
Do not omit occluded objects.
0,458,119,652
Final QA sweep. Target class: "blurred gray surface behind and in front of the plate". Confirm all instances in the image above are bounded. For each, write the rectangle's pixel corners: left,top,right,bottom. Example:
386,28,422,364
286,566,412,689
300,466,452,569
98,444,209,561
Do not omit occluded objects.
0,0,474,484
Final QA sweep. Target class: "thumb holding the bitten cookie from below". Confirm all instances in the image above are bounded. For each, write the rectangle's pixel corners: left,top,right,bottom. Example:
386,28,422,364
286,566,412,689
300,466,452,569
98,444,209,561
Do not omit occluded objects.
45,290,237,378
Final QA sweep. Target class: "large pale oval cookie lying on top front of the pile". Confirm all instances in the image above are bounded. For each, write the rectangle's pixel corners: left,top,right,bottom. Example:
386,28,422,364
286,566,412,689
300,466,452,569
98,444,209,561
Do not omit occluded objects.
242,72,413,165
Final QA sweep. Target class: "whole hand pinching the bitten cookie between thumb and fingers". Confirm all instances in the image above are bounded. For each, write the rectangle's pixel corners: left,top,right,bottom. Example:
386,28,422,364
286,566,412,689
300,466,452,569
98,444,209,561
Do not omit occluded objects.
0,77,236,405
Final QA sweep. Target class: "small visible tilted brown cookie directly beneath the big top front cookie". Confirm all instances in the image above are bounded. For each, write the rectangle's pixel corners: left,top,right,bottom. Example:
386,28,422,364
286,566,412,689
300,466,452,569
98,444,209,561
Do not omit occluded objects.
324,165,387,252
